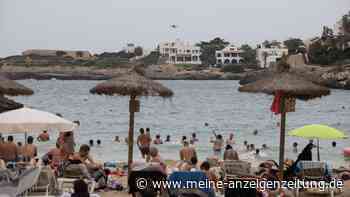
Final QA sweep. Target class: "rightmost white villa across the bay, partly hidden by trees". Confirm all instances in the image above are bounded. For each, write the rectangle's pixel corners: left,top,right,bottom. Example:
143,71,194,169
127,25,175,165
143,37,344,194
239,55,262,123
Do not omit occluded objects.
256,44,288,68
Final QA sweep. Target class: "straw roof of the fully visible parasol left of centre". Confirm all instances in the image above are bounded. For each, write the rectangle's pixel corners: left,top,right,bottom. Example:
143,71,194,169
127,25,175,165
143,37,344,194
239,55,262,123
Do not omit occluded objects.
90,72,174,97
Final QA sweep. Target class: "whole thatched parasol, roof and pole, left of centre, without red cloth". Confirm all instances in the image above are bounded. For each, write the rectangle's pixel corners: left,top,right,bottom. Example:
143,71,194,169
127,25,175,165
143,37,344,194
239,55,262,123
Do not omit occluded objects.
90,72,173,177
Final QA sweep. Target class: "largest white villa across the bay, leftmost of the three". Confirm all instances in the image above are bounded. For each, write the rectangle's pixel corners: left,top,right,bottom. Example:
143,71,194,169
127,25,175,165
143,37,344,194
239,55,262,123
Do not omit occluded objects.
159,39,202,64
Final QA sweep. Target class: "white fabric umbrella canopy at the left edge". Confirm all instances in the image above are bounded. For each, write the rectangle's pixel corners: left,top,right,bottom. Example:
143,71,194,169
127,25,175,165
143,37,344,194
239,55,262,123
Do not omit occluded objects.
0,107,77,133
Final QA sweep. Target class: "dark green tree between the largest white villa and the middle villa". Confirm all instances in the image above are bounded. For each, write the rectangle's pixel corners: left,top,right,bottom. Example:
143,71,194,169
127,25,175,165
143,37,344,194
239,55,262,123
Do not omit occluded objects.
197,37,229,65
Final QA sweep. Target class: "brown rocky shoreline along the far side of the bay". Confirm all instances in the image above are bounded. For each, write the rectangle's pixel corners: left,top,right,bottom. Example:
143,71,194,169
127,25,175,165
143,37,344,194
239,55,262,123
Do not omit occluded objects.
0,60,350,90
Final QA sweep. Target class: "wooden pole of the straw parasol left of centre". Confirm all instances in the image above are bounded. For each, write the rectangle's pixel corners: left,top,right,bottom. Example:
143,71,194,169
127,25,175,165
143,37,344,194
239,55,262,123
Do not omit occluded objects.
128,95,136,178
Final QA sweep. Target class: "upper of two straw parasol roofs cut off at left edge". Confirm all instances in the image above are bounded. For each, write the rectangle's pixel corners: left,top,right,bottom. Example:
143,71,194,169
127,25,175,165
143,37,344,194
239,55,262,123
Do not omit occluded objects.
0,76,34,96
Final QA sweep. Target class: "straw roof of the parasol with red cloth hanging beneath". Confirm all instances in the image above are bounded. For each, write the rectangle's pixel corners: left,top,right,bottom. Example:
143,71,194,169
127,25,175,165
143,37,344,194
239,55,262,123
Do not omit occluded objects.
239,72,330,100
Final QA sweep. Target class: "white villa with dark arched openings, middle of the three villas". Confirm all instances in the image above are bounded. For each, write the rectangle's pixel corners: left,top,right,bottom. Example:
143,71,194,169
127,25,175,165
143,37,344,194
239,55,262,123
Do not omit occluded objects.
215,44,244,65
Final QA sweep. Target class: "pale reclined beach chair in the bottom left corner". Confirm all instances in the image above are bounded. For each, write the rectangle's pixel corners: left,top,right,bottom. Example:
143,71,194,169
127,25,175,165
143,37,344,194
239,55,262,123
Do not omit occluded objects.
0,168,40,197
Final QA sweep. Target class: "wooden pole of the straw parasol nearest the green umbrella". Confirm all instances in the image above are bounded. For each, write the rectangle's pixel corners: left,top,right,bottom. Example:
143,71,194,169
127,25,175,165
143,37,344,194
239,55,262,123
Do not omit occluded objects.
279,95,286,180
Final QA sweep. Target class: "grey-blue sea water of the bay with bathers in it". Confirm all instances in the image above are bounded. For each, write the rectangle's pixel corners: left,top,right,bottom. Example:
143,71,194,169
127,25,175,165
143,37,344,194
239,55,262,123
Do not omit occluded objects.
7,80,350,166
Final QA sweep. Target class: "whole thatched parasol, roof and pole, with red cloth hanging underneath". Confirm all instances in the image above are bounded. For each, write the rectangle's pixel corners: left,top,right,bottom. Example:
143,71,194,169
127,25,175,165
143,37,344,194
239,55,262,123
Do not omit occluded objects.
239,62,330,178
